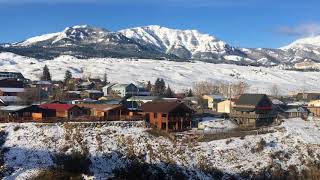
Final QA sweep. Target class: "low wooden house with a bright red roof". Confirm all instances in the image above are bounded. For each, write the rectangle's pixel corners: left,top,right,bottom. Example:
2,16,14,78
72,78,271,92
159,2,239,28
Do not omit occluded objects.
39,104,82,119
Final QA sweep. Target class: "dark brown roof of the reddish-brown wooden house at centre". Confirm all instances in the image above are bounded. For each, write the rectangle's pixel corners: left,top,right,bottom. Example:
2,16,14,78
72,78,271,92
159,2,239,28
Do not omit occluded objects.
141,101,192,113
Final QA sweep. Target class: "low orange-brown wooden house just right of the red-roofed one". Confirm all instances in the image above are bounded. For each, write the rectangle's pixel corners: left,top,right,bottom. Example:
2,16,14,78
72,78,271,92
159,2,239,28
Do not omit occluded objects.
78,104,122,121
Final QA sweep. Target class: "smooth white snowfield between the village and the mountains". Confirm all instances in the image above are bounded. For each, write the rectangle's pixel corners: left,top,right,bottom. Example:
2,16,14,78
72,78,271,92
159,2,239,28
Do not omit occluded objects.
0,53,320,94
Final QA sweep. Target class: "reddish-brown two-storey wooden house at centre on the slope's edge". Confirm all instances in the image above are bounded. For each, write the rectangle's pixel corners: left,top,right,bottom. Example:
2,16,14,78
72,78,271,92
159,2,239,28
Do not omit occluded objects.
141,101,193,132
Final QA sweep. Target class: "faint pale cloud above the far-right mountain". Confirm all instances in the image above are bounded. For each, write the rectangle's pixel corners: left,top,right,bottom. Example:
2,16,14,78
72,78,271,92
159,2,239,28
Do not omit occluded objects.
275,23,320,36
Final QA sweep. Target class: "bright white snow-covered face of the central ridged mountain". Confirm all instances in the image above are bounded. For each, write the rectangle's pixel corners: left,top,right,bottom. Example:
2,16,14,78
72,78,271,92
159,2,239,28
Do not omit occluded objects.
119,25,243,59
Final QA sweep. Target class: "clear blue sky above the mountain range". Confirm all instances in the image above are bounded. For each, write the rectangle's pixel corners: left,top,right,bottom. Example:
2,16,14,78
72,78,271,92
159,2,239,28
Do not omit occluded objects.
0,0,320,48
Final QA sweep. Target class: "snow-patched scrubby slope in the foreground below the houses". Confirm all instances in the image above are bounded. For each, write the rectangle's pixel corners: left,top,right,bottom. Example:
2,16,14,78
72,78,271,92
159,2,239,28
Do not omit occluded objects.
0,119,320,179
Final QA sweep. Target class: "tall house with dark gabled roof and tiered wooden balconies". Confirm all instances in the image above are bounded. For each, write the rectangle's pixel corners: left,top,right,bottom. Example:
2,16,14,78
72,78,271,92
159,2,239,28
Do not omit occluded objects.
230,94,277,128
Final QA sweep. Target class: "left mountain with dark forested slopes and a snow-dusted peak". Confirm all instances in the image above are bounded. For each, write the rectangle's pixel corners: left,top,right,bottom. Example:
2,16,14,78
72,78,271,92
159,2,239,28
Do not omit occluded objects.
4,25,172,59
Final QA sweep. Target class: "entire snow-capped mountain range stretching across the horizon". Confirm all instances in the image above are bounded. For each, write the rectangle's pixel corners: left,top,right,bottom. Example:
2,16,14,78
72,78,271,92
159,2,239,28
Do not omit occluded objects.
0,25,320,69
